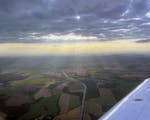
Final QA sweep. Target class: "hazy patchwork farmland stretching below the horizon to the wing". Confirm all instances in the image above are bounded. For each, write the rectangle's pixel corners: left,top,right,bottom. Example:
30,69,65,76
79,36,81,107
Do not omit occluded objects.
0,55,150,120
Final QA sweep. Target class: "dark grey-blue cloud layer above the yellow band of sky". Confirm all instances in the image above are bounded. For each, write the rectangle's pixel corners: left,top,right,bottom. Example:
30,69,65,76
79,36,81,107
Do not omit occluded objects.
0,0,150,42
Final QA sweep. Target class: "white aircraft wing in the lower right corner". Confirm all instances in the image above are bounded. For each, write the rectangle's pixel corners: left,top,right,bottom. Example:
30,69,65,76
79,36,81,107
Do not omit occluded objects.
99,79,150,120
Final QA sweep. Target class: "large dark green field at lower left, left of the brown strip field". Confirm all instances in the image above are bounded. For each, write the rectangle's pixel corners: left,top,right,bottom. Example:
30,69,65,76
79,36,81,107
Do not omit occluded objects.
19,95,60,120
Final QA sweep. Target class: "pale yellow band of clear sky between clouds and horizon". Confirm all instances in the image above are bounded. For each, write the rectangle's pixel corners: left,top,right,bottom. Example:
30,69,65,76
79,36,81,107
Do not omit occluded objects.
0,40,150,56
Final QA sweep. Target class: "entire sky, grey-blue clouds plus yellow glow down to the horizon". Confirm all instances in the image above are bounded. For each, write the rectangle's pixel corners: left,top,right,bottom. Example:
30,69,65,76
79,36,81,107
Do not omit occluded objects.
0,0,150,55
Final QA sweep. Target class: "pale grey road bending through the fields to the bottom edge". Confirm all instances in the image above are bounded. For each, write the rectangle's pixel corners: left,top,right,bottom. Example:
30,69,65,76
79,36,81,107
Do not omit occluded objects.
62,71,87,120
